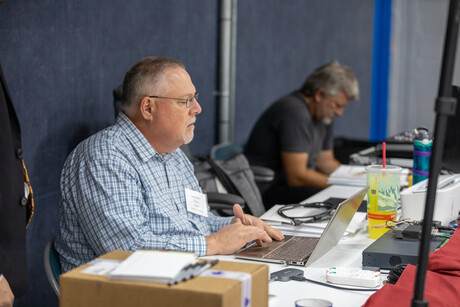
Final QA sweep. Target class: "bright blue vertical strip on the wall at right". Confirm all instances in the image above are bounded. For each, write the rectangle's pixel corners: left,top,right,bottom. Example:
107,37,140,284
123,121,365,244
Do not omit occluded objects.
370,0,392,142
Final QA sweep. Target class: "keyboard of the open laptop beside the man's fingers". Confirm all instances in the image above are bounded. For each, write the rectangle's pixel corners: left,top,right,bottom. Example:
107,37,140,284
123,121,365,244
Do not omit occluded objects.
264,237,319,260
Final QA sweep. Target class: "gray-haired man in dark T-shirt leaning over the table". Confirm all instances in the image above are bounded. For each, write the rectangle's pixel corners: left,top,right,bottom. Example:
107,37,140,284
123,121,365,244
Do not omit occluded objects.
245,61,359,208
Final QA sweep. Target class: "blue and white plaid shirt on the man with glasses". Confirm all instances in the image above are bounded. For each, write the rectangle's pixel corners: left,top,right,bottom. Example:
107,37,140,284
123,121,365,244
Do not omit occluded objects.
56,113,231,272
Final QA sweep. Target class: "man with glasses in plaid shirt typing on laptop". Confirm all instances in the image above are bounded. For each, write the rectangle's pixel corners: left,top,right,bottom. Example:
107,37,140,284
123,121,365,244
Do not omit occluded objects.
56,57,284,272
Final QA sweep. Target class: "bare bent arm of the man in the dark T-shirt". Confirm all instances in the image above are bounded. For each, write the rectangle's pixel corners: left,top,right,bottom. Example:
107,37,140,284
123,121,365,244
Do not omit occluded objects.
281,151,328,188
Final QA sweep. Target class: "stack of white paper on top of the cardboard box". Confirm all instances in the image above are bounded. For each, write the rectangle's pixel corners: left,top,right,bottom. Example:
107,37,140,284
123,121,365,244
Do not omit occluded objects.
109,250,197,283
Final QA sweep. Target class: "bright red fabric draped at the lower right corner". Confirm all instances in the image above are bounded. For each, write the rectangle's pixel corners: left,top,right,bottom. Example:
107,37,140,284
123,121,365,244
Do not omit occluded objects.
364,229,460,307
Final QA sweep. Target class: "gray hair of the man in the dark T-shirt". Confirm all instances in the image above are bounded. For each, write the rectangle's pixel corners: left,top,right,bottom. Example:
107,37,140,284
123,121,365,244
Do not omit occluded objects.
300,61,359,100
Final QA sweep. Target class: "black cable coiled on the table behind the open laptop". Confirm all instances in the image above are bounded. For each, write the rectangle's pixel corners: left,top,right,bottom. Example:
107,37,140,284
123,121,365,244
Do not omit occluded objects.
278,202,335,226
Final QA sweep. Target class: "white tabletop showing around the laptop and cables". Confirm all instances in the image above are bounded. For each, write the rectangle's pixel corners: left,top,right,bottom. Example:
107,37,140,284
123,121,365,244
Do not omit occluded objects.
207,185,380,307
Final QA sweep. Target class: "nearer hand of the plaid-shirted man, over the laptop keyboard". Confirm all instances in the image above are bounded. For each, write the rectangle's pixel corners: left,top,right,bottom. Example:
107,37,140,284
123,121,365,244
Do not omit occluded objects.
206,218,272,256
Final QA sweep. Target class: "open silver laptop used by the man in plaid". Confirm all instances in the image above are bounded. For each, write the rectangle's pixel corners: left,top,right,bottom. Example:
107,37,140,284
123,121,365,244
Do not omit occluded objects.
235,186,369,267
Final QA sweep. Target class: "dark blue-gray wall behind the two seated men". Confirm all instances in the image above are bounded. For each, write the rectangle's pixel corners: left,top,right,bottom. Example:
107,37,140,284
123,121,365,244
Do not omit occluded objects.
0,0,374,306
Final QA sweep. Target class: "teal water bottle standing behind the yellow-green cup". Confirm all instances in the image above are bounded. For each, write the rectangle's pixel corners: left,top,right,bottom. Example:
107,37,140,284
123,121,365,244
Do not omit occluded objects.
412,128,433,184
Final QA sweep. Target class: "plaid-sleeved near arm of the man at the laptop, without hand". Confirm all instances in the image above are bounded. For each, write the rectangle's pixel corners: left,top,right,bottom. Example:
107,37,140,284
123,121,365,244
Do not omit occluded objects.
67,159,207,256
